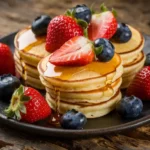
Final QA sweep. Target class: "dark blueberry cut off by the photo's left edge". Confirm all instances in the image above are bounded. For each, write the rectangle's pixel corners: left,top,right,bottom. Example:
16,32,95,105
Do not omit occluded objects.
0,74,20,102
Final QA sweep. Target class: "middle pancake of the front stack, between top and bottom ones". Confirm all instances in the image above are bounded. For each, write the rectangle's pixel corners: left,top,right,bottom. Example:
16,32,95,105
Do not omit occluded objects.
43,78,122,104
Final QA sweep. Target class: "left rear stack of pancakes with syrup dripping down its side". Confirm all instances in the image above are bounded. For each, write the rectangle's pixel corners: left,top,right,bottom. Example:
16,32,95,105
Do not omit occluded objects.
14,27,49,89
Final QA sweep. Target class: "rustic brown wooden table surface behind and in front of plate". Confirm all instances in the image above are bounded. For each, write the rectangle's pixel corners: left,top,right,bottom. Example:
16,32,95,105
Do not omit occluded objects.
0,0,150,150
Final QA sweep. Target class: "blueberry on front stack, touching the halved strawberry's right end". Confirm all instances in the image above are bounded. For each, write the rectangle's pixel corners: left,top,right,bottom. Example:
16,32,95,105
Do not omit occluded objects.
94,38,115,62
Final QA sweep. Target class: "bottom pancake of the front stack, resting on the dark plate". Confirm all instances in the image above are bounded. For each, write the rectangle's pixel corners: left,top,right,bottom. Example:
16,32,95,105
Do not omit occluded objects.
46,91,121,118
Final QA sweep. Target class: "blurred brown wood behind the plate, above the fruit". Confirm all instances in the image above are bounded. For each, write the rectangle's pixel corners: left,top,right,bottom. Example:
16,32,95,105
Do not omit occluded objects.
0,0,150,37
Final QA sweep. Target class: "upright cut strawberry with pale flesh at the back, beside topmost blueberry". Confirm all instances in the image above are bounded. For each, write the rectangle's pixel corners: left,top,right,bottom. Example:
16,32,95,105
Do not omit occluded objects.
88,5,117,41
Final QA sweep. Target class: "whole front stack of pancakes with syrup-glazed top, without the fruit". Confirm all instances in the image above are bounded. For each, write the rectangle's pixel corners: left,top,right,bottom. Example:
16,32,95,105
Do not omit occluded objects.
38,54,123,118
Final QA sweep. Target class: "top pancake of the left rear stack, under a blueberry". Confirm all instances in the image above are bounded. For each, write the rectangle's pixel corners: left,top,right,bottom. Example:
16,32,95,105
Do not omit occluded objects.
14,27,49,67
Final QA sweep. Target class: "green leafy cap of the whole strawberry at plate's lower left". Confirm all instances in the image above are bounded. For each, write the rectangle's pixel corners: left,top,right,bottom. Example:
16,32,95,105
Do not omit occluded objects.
4,85,30,120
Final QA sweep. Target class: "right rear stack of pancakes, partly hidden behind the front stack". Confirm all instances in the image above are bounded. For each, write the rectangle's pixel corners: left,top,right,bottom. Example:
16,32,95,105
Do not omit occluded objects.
112,26,145,89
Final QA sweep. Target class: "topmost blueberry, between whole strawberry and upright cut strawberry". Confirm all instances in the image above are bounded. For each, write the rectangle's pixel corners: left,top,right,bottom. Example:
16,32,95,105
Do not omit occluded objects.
73,4,92,23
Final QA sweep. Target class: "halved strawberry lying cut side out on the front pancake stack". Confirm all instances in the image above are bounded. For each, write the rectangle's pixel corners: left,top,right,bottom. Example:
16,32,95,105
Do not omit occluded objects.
49,36,95,66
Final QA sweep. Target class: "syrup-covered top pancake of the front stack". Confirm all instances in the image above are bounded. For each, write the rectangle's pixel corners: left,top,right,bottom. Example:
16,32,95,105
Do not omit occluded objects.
38,54,123,91
